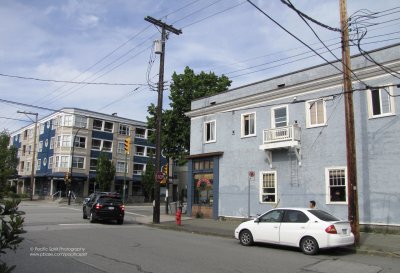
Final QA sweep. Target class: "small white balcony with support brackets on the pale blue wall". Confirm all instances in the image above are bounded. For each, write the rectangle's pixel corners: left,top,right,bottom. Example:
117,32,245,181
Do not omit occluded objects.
259,124,301,167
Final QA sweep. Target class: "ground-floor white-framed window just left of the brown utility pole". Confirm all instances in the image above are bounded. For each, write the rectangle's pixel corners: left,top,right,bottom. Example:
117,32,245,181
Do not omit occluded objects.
325,167,347,204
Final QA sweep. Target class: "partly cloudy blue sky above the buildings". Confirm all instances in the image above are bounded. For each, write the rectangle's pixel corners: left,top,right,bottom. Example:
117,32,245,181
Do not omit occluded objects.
0,0,400,132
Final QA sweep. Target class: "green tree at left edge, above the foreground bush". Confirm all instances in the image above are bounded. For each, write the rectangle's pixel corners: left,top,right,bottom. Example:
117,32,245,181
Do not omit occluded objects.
0,131,18,196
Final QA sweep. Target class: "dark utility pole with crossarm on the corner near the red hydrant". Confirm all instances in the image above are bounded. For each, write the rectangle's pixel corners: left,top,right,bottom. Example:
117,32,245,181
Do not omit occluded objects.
144,16,182,224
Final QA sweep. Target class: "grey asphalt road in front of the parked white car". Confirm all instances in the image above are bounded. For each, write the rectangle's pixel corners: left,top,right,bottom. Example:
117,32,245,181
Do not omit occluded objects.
2,202,400,273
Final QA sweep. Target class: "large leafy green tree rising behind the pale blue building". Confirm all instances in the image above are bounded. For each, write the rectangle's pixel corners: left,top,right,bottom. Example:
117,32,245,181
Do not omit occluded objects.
147,67,231,162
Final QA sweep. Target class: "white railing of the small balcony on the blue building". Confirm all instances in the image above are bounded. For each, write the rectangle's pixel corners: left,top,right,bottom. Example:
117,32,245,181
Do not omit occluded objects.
263,124,300,144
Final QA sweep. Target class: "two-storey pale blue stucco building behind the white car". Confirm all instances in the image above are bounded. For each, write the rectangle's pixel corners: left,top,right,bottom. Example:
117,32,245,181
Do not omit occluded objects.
187,44,400,226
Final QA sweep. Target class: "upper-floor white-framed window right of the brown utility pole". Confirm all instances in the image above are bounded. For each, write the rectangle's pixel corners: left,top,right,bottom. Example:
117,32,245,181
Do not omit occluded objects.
367,87,395,118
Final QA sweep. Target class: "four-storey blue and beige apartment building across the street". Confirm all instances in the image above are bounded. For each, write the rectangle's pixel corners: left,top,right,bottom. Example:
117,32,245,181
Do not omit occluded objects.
10,108,161,201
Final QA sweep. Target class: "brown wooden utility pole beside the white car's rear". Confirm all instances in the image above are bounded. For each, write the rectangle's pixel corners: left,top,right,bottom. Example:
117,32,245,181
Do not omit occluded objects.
339,0,360,245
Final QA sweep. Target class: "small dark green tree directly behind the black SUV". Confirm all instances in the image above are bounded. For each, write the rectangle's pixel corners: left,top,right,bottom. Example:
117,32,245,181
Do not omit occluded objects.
96,151,115,191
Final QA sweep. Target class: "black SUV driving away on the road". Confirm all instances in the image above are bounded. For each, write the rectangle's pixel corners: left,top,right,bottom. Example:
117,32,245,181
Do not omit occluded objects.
83,192,125,225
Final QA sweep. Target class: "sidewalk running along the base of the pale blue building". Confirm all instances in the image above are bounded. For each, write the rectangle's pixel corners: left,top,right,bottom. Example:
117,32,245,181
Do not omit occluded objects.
143,214,400,258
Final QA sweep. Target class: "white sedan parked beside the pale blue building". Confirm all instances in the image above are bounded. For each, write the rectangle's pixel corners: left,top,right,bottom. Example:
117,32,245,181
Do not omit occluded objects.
235,208,354,255
